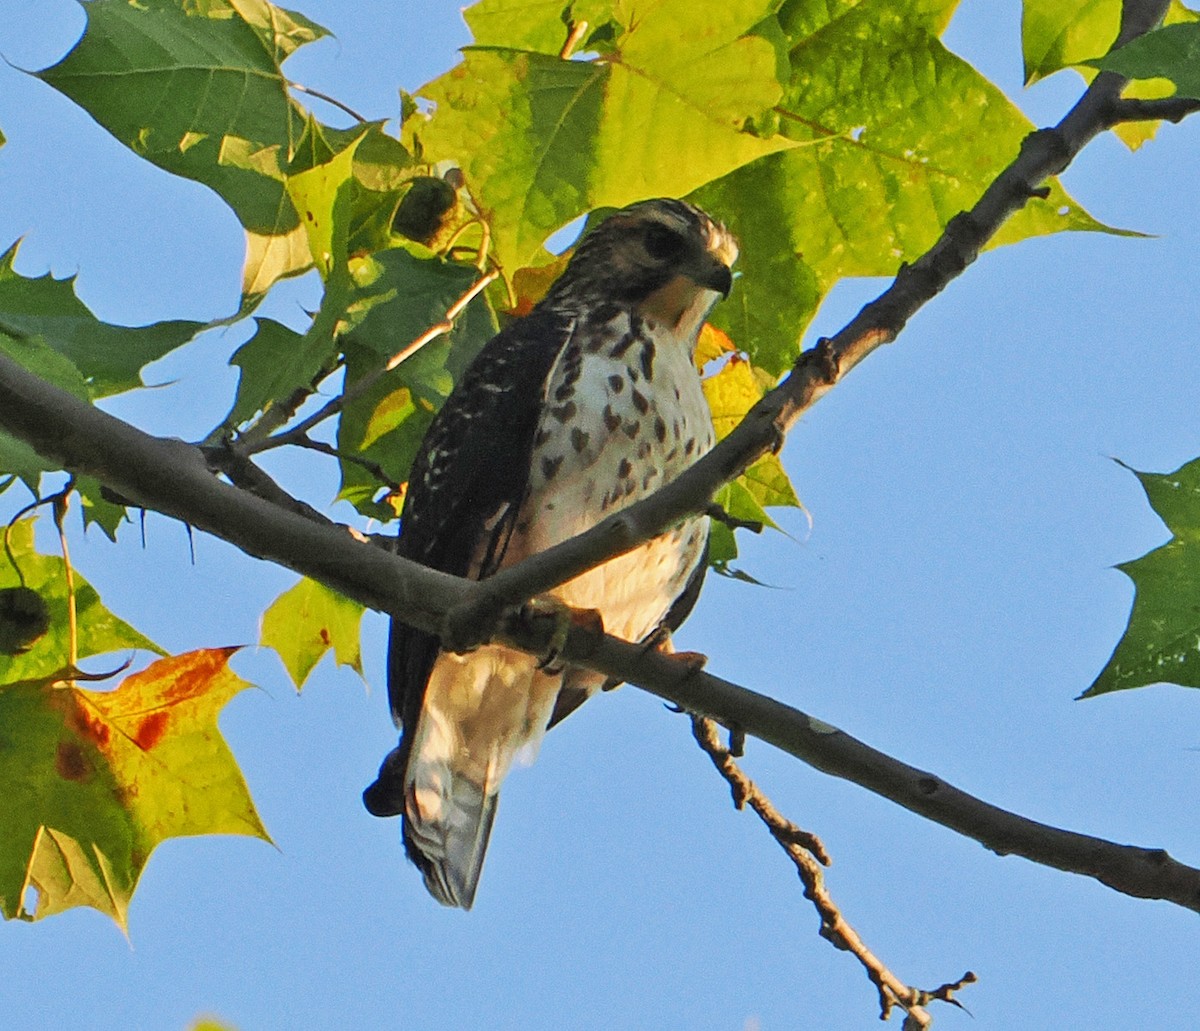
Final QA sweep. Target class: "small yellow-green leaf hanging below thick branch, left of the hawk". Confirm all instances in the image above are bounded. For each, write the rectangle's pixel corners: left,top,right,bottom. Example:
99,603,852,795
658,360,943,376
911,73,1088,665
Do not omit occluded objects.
258,579,364,690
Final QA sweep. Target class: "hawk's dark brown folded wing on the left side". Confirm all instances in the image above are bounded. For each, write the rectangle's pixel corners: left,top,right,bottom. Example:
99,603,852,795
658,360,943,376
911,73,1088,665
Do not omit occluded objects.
364,304,575,815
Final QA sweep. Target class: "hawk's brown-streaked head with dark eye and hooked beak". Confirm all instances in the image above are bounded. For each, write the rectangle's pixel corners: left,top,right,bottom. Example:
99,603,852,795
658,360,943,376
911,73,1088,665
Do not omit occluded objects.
545,198,738,322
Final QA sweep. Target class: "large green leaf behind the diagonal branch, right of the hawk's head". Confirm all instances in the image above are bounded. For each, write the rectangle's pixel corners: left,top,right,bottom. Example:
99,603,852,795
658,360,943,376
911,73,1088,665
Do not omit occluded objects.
690,0,1105,374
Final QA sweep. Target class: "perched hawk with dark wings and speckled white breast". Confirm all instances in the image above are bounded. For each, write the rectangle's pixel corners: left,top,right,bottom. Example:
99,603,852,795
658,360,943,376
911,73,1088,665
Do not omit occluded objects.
364,199,737,910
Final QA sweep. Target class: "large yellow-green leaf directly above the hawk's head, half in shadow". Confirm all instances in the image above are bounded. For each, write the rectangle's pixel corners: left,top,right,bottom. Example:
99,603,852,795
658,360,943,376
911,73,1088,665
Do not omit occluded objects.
410,0,792,269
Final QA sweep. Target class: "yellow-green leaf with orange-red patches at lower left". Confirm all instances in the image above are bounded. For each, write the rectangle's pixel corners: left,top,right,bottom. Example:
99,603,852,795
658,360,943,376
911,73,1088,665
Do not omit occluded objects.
0,648,270,929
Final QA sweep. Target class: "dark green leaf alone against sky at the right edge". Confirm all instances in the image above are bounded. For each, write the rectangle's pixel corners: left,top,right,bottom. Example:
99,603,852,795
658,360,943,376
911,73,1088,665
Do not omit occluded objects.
1081,458,1200,697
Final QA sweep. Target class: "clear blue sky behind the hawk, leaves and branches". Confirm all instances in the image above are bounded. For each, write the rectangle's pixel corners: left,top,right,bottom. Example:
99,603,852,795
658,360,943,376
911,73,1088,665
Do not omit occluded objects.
0,0,1200,1031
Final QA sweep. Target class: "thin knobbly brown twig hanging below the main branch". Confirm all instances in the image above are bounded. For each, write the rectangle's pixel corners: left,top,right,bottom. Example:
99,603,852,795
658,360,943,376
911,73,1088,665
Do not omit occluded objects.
689,713,976,1027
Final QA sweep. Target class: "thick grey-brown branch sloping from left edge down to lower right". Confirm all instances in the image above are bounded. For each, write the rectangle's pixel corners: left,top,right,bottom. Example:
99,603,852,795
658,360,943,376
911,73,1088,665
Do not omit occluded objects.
0,354,1200,912
